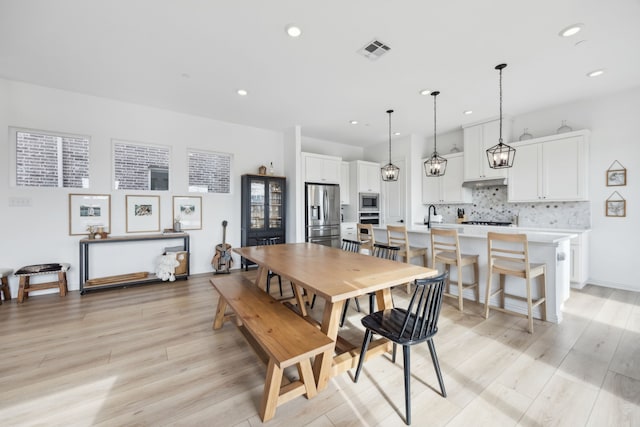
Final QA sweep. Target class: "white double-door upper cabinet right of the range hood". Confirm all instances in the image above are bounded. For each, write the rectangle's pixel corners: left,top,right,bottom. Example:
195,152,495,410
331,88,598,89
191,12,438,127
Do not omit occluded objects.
508,130,589,202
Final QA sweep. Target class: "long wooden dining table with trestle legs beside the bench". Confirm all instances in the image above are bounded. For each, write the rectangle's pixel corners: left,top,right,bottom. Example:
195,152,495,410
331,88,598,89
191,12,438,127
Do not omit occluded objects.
234,243,437,390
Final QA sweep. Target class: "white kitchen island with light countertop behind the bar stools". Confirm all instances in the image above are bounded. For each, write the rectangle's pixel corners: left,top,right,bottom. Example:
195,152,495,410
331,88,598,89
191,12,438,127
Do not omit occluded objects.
374,224,576,323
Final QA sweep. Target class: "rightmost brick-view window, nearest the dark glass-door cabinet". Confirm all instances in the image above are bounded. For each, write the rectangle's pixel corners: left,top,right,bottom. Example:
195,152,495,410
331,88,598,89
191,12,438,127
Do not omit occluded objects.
189,150,232,194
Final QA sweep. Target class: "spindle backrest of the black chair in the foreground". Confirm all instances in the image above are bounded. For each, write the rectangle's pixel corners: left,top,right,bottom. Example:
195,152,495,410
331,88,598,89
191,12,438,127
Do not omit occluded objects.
399,271,449,344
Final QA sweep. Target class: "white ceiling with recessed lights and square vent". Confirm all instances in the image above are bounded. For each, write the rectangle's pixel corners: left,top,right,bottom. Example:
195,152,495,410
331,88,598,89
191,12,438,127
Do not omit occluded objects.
0,0,640,146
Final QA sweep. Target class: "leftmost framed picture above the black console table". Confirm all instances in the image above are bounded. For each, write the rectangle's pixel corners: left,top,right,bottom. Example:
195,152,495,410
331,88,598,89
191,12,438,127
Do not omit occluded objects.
69,194,111,236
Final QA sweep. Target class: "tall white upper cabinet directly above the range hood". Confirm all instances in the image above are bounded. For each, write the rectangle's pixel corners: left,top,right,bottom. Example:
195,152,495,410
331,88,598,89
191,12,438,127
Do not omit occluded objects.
464,117,511,181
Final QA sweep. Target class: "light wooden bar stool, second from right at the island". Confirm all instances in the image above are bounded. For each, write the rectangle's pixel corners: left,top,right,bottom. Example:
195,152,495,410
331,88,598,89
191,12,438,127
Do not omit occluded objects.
431,228,480,311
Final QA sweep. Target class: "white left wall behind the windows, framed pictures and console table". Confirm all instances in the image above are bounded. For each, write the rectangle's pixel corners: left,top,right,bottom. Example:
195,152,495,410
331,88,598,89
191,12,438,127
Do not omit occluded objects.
0,80,285,295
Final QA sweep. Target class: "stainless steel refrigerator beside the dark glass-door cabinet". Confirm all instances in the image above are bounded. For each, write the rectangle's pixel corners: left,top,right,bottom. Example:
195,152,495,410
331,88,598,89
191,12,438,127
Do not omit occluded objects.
305,183,340,248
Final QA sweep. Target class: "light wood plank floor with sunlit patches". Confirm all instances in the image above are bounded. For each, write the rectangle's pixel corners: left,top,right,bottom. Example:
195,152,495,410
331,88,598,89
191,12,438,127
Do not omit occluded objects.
0,272,640,427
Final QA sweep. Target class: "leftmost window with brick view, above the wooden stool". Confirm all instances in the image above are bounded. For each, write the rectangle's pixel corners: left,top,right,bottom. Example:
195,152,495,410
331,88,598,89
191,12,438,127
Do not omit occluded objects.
10,128,90,188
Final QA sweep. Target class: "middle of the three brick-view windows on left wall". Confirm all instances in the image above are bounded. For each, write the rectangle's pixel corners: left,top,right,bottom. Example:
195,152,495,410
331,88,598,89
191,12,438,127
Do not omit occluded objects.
113,140,171,190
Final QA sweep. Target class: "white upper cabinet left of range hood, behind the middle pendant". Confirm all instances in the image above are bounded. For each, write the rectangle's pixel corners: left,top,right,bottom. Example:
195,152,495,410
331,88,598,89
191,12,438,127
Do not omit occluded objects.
422,153,472,205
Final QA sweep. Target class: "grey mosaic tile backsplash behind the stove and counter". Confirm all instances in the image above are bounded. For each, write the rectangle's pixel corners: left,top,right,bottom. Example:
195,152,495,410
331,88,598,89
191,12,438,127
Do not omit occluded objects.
425,185,591,229
